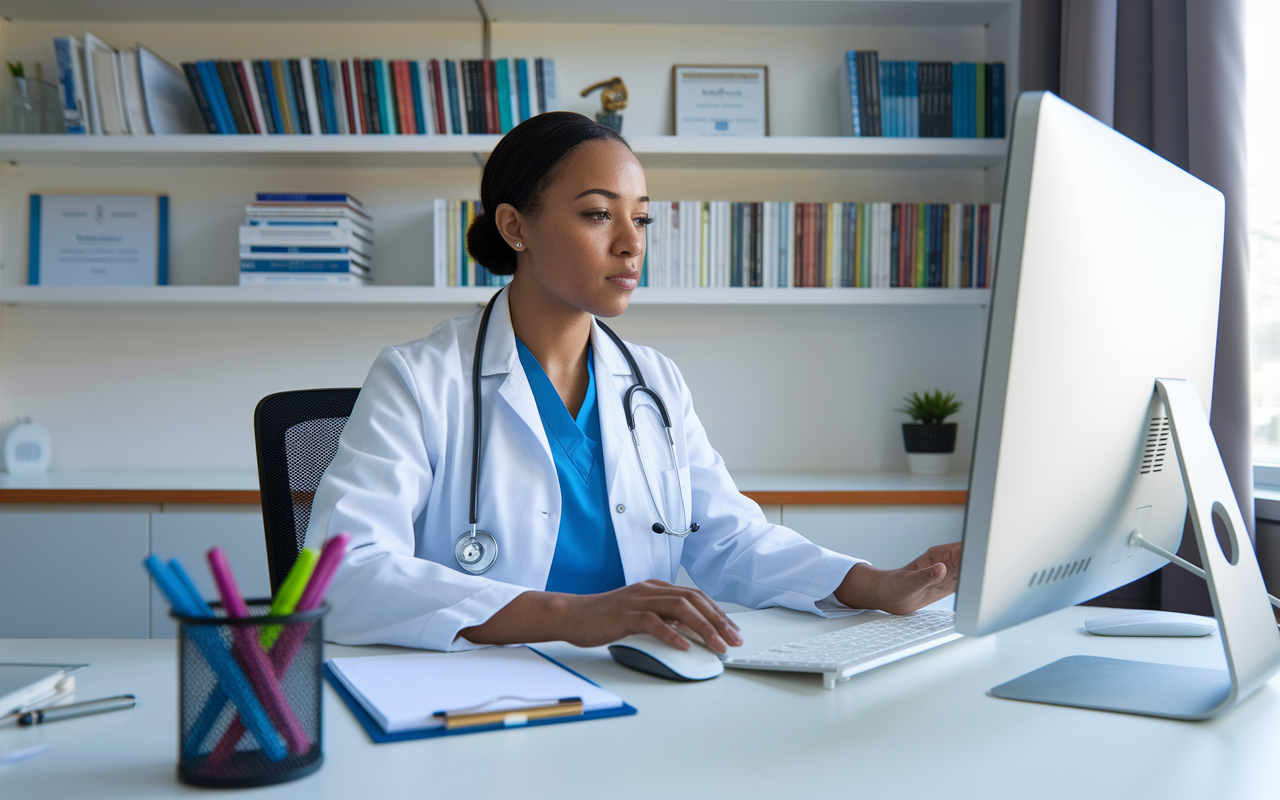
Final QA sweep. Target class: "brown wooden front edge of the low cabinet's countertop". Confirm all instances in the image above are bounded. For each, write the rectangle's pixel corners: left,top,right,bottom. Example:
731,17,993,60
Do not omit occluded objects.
0,489,968,506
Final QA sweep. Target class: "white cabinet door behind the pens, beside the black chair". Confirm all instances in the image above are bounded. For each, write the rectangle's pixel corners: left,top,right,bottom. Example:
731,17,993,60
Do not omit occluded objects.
151,513,271,639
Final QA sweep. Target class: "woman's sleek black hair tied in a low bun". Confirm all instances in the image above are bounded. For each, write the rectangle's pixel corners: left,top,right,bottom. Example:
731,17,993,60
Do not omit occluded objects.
467,111,627,275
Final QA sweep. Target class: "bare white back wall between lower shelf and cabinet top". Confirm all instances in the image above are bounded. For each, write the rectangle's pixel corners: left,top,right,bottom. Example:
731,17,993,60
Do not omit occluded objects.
0,299,986,471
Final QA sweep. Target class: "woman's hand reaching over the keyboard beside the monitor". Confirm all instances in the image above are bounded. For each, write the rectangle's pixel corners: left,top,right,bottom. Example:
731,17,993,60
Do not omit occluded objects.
836,541,960,614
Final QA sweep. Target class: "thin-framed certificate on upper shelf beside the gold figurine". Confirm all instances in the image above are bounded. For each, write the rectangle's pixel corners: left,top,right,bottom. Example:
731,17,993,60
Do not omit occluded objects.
671,64,769,136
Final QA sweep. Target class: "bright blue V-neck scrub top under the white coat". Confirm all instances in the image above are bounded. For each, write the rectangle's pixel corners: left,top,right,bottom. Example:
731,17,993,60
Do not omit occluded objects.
516,338,626,594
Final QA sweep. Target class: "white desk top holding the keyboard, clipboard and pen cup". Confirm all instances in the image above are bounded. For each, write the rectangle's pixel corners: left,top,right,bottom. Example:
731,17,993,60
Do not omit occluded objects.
0,608,1280,800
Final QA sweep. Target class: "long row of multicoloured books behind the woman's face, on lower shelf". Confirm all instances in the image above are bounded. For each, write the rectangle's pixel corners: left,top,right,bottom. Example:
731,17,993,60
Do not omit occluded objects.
434,200,1000,288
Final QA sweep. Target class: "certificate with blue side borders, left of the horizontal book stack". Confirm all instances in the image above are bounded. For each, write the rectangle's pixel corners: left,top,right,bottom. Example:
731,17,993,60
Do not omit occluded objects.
27,195,169,287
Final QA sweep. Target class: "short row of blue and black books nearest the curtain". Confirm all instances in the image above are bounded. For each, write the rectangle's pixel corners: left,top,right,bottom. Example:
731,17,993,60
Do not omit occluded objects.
840,50,1005,138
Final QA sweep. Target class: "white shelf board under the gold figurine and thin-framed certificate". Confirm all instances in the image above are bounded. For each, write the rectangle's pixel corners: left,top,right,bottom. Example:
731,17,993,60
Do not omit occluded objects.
0,134,1006,169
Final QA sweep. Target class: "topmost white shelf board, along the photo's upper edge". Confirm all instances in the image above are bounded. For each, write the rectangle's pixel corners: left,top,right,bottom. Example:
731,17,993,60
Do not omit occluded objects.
5,0,1010,26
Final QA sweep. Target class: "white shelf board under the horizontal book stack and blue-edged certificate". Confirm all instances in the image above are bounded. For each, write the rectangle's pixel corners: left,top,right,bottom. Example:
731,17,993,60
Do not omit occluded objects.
0,287,991,306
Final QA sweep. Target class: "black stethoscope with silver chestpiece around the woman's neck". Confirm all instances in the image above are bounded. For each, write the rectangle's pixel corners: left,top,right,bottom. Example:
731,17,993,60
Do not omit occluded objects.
453,292,698,575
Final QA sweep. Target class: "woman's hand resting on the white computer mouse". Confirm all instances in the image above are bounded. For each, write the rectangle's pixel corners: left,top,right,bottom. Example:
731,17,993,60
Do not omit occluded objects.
564,580,742,653
